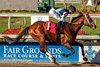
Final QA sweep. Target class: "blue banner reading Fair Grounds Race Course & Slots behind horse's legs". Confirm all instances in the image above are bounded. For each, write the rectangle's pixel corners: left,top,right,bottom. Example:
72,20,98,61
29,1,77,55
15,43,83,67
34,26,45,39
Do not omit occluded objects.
0,42,79,62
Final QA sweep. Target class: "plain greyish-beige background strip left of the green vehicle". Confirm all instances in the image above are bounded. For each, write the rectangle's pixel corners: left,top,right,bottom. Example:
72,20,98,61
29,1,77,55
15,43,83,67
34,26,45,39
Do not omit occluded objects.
0,0,38,11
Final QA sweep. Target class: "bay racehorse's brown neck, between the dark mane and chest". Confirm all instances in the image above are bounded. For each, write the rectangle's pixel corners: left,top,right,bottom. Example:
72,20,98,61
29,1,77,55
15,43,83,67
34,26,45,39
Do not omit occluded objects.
71,17,84,34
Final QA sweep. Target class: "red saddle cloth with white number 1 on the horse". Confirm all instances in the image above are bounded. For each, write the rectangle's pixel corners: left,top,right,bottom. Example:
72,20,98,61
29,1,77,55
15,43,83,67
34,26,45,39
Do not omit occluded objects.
46,21,62,34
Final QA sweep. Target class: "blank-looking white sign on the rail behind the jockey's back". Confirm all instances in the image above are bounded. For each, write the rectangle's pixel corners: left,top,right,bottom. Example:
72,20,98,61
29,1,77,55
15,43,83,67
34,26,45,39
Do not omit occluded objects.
31,14,49,24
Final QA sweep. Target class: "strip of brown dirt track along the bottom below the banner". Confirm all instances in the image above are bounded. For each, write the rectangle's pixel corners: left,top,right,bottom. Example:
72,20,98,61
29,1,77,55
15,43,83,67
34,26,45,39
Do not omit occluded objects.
0,62,100,67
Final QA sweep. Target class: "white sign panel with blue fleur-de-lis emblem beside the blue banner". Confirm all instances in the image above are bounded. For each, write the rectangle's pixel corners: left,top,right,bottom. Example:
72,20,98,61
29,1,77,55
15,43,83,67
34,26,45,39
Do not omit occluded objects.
79,43,100,62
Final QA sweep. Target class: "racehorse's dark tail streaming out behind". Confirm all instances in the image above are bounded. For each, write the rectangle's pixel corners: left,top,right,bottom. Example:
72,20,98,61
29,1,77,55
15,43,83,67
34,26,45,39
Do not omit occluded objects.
3,27,29,44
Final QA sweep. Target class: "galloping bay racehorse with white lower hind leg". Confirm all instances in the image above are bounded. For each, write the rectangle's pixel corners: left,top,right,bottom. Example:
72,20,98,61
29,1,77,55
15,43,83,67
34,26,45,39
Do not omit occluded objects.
4,13,96,63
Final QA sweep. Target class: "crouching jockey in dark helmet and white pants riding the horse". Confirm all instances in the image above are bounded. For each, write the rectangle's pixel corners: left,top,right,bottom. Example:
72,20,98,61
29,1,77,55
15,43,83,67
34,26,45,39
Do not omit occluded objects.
49,5,76,43
